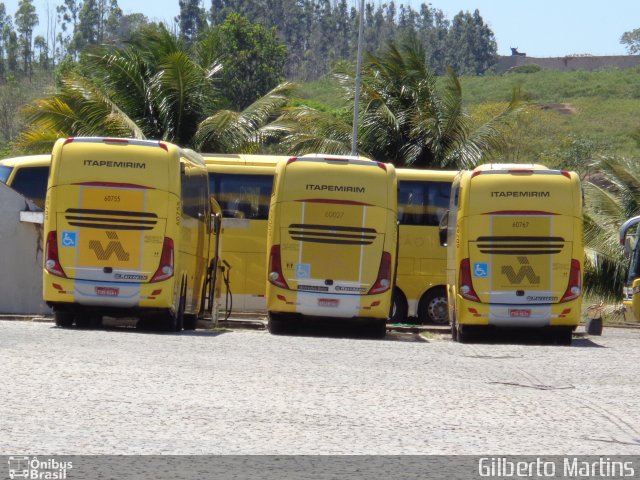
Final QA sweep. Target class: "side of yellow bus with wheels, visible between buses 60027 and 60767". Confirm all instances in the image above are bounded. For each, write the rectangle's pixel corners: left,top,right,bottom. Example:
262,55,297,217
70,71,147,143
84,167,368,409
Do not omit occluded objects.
391,168,458,324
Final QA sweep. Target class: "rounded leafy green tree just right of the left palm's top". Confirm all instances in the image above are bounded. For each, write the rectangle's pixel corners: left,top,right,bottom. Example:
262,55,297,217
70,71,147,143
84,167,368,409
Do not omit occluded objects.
204,13,287,110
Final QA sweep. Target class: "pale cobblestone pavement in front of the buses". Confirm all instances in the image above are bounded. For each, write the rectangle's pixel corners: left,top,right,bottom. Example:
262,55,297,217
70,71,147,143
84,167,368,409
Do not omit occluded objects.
0,321,640,455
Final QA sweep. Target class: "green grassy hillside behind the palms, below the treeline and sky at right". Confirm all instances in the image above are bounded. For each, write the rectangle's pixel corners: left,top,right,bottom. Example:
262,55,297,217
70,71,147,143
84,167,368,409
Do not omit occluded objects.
301,68,640,166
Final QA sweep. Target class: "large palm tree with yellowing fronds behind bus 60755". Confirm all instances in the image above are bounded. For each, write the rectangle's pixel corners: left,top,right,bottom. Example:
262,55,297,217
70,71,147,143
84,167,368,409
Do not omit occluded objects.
17,25,294,152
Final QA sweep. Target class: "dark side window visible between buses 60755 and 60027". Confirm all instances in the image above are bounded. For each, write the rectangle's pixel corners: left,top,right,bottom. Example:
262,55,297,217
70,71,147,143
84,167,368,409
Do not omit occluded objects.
209,173,273,220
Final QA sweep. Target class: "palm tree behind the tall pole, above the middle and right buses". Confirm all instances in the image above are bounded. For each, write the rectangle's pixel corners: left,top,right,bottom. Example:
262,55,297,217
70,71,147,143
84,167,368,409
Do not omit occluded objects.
266,42,518,168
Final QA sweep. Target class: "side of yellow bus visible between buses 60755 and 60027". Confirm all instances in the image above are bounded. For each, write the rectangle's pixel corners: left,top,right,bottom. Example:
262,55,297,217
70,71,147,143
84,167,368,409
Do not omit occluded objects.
202,153,289,313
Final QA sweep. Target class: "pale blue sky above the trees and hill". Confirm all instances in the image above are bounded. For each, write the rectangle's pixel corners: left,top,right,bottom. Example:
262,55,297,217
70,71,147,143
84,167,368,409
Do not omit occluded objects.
4,0,640,57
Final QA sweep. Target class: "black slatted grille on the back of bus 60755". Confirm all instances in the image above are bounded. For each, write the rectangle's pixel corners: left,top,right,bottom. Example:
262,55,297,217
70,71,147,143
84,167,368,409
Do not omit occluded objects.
65,208,158,230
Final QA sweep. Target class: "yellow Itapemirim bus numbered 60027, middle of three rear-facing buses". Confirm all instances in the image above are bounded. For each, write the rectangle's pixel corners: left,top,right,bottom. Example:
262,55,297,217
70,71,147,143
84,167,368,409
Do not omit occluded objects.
266,154,398,336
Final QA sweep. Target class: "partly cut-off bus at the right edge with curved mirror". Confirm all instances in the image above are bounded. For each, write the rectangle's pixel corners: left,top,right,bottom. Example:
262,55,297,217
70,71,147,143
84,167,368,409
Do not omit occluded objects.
620,216,640,322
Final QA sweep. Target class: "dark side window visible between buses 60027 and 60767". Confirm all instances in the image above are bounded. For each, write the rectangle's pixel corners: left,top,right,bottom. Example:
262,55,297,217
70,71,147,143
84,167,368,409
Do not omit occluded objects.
398,180,451,227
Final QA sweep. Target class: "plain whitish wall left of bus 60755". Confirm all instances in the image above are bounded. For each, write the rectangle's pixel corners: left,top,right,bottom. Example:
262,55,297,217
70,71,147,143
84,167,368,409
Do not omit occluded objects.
0,183,51,314
